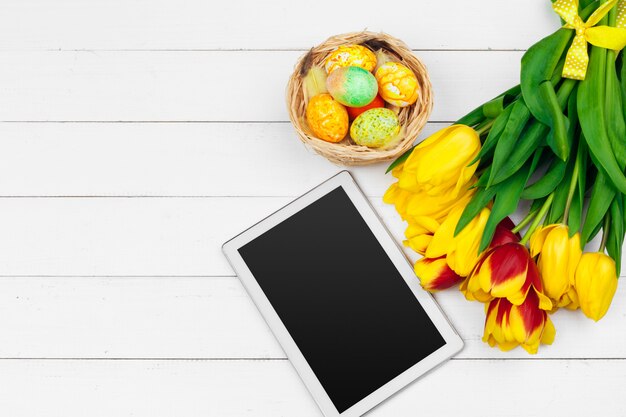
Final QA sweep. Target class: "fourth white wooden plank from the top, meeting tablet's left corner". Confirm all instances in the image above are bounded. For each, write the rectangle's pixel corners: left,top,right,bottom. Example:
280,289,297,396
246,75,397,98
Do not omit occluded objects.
0,196,626,276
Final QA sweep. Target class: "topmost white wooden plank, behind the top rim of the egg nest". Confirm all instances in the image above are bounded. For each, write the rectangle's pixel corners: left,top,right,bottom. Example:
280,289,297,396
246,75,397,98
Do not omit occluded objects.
0,0,559,49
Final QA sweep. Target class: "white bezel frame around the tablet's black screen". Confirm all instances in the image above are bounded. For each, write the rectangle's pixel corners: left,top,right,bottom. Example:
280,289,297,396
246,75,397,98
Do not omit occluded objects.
222,171,463,417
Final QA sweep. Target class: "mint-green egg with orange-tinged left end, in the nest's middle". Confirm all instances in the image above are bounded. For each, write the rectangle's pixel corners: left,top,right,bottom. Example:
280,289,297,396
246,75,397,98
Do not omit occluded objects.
326,67,378,107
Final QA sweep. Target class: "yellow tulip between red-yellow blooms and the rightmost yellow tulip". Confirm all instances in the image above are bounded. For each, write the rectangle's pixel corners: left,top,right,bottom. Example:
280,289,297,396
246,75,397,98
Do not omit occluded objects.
530,224,582,309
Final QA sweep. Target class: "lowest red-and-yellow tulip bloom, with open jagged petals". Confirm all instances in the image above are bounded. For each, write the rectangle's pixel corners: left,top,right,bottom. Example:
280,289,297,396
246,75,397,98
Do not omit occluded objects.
483,290,556,354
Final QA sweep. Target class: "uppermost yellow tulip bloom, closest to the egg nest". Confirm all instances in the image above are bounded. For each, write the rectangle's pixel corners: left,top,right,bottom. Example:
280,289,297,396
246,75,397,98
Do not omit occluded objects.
399,125,481,197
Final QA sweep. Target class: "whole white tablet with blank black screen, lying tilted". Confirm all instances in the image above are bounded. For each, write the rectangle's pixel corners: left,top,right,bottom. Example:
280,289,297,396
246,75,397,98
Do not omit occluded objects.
223,171,463,417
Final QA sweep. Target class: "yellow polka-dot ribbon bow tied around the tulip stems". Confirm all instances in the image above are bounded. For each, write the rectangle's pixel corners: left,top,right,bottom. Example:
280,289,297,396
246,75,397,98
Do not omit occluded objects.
552,0,626,80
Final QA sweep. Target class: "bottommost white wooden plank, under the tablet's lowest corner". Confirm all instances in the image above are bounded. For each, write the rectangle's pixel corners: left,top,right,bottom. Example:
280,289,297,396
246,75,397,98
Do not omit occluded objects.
0,360,626,417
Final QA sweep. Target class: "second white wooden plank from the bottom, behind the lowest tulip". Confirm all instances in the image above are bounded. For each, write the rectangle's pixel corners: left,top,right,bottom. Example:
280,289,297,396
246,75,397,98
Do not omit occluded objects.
0,277,626,360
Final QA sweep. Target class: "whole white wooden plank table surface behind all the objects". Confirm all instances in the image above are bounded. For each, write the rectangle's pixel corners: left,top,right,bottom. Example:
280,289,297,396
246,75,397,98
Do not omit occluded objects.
0,0,626,417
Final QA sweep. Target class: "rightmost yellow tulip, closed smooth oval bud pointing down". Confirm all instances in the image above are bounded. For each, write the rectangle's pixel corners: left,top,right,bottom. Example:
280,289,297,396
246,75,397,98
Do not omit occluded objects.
575,252,617,321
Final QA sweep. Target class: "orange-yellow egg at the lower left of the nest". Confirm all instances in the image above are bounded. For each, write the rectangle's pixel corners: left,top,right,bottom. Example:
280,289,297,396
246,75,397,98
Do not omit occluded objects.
306,94,348,142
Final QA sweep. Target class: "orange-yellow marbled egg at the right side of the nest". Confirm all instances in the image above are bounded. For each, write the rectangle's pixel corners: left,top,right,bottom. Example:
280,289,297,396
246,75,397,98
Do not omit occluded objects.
376,62,420,107
